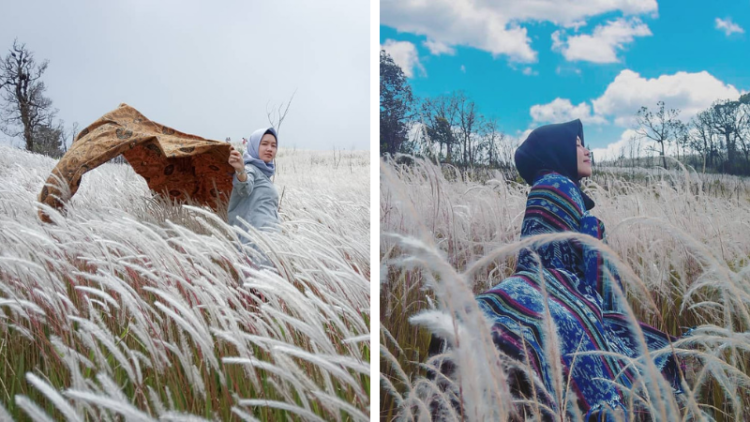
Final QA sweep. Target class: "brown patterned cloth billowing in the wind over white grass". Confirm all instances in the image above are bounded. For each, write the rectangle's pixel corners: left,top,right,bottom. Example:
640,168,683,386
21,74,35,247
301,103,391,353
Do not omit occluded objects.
39,104,234,222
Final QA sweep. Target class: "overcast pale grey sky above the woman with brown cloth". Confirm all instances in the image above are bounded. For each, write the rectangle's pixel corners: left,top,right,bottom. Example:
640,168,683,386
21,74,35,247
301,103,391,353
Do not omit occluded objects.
0,0,370,150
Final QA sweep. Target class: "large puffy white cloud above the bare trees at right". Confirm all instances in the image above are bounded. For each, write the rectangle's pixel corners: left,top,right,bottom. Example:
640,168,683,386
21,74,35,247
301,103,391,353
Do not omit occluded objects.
591,69,740,126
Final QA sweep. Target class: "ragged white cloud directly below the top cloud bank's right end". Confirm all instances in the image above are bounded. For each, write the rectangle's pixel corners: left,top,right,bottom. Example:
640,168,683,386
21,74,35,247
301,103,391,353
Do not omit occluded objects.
552,18,651,63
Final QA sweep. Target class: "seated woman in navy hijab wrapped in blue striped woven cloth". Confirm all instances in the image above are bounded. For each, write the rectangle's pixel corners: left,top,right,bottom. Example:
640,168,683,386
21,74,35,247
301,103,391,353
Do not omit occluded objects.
477,120,679,420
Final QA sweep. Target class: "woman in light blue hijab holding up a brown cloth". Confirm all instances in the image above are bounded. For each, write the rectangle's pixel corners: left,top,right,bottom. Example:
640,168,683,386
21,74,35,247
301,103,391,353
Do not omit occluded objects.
227,127,279,264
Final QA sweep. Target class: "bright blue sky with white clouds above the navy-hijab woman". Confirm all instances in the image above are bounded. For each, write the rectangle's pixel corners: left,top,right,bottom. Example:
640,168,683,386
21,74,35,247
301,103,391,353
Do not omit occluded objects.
380,0,750,155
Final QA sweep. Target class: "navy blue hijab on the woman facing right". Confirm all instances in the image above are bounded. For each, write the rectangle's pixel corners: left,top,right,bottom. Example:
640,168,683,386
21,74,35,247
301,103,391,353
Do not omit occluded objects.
515,119,595,210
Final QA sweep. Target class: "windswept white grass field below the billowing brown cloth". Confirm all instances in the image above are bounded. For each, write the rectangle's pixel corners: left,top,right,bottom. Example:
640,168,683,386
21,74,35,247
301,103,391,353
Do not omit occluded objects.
0,143,371,421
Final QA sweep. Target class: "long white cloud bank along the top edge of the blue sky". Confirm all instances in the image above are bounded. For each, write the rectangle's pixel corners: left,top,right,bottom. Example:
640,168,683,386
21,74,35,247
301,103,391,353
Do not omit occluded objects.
380,0,657,62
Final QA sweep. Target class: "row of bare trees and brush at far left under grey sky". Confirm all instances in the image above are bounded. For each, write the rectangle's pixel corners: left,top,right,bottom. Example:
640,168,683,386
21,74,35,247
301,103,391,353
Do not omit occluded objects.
0,41,78,157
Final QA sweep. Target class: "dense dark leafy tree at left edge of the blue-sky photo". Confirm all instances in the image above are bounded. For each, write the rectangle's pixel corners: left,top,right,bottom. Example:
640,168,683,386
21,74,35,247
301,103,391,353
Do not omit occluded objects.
380,50,414,155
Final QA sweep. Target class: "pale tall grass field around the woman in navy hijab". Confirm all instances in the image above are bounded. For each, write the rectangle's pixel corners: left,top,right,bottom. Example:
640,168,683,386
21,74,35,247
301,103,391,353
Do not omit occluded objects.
380,160,750,421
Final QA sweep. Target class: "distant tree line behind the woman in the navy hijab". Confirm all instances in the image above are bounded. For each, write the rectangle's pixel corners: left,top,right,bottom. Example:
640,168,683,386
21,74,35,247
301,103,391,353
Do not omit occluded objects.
380,50,750,175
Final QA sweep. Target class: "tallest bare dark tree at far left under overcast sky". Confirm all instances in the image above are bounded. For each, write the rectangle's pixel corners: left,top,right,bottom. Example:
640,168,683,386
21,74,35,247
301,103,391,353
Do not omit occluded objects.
0,40,57,151
